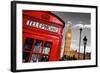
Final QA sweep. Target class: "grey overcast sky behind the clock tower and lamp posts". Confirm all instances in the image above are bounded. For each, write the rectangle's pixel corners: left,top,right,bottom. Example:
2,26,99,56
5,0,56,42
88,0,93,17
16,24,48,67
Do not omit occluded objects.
52,12,91,56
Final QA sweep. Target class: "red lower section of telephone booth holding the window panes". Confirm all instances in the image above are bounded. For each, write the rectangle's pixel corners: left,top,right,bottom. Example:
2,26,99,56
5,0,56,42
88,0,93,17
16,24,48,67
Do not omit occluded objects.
23,33,58,62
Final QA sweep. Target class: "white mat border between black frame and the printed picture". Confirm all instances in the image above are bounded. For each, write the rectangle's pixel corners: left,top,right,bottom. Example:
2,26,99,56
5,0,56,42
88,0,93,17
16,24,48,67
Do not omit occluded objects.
11,0,96,70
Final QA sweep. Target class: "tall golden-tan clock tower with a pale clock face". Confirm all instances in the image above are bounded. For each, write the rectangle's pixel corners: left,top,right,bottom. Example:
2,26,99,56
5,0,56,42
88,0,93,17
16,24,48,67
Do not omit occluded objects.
64,22,72,56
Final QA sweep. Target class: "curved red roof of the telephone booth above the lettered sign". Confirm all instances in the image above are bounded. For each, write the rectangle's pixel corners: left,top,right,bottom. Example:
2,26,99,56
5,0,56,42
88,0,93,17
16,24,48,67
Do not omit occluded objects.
23,10,65,27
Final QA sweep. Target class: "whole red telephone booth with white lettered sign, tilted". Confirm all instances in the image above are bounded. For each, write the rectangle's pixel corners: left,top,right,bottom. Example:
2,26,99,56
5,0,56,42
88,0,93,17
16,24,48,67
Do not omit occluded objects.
22,10,64,62
